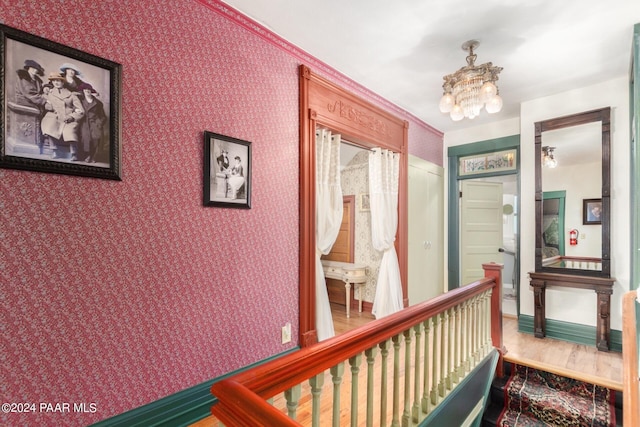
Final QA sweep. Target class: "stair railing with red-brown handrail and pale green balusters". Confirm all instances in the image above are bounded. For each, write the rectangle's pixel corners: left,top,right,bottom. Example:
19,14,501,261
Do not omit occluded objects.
211,263,505,426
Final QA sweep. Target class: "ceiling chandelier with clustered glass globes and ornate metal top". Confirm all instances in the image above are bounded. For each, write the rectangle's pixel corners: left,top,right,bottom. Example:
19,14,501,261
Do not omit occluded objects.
440,40,502,122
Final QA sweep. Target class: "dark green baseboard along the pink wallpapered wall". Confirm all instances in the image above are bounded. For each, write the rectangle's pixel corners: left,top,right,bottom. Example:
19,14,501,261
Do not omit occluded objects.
93,347,300,427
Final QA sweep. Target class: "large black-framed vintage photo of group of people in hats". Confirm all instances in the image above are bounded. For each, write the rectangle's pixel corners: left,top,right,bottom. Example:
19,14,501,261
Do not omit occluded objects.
0,24,122,180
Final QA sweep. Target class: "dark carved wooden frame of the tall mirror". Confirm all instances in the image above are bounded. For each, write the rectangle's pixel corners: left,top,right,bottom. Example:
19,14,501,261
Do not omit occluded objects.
535,107,611,277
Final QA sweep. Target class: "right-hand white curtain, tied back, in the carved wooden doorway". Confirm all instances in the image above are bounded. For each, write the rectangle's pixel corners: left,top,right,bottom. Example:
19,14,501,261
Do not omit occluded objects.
369,148,402,319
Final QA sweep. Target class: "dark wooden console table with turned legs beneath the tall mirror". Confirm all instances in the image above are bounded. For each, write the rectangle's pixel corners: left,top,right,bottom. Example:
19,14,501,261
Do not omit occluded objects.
529,272,616,351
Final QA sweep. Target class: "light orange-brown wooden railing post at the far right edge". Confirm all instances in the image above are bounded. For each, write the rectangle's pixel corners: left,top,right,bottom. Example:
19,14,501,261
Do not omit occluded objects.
622,291,640,426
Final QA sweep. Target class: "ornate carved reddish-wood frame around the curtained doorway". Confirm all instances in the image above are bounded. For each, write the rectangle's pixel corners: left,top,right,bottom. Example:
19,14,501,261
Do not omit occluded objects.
299,65,409,347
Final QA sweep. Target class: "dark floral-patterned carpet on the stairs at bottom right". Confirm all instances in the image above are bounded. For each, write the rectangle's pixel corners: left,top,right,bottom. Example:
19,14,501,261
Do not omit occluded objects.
497,364,616,427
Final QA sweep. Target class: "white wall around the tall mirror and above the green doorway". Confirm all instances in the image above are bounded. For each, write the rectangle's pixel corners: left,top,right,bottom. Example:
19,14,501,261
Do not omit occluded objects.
444,76,630,330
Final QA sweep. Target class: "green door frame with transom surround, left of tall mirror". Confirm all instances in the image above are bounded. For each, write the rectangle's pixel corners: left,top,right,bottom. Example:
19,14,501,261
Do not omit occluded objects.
447,135,521,292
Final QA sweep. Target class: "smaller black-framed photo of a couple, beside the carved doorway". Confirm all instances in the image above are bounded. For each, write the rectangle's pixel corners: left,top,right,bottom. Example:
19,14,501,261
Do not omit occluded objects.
204,131,251,209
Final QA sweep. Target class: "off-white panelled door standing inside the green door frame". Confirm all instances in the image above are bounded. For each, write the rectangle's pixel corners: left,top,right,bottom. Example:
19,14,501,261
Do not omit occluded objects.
460,180,503,286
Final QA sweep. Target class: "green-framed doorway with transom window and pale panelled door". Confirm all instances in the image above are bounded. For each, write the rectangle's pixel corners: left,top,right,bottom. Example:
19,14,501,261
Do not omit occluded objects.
447,135,520,316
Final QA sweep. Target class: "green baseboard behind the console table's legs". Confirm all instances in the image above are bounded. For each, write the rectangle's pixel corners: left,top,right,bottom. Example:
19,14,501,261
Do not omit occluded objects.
518,314,622,353
